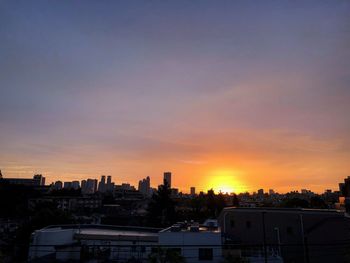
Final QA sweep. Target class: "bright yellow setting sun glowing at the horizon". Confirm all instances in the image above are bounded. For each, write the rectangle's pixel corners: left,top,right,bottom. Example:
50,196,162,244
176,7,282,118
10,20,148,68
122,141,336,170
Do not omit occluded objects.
207,169,242,194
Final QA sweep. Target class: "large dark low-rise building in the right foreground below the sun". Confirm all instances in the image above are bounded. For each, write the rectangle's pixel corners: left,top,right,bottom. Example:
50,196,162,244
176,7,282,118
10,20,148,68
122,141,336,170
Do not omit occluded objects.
219,207,350,263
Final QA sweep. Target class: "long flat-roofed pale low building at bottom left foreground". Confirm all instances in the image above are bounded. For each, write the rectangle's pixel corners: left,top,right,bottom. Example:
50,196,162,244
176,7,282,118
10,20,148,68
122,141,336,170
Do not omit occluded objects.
28,225,159,262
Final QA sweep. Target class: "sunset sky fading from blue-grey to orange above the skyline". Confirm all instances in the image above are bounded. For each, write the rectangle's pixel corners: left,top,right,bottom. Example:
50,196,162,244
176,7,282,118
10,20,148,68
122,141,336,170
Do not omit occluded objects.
0,0,350,192
